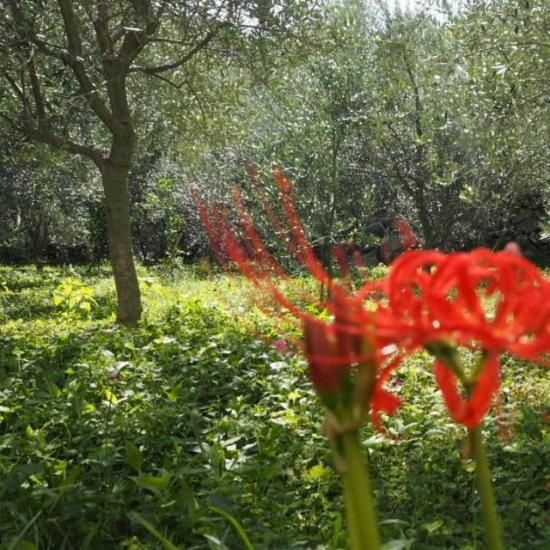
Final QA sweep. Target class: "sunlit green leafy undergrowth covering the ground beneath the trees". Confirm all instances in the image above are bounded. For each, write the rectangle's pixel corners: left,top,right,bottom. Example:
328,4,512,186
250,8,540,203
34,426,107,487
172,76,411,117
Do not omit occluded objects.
0,267,550,550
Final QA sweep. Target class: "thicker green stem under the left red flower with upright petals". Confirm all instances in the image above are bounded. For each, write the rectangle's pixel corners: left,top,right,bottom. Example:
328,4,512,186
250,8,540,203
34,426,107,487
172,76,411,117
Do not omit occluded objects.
336,430,380,550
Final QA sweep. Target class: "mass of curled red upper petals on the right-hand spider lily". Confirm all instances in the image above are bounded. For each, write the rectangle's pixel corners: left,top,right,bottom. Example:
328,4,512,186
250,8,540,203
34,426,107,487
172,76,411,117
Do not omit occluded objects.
385,248,550,360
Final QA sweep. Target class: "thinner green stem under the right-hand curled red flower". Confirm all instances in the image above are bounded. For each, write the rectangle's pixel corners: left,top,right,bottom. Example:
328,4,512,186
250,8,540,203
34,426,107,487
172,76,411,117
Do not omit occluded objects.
468,424,504,550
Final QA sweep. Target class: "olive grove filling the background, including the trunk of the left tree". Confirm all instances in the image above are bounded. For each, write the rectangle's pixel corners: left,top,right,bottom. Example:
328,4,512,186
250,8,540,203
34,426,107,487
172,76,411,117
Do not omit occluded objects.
0,0,550,310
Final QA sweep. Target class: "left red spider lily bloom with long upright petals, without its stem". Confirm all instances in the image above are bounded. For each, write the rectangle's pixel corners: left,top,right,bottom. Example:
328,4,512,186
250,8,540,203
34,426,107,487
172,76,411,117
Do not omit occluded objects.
197,168,408,424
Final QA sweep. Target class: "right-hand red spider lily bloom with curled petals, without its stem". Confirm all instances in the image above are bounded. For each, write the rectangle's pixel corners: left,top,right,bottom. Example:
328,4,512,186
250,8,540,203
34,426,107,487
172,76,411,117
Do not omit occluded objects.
384,248,550,428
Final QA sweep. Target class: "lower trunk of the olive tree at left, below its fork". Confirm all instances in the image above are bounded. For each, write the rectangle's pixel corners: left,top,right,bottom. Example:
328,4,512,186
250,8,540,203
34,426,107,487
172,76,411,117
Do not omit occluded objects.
101,155,142,326
